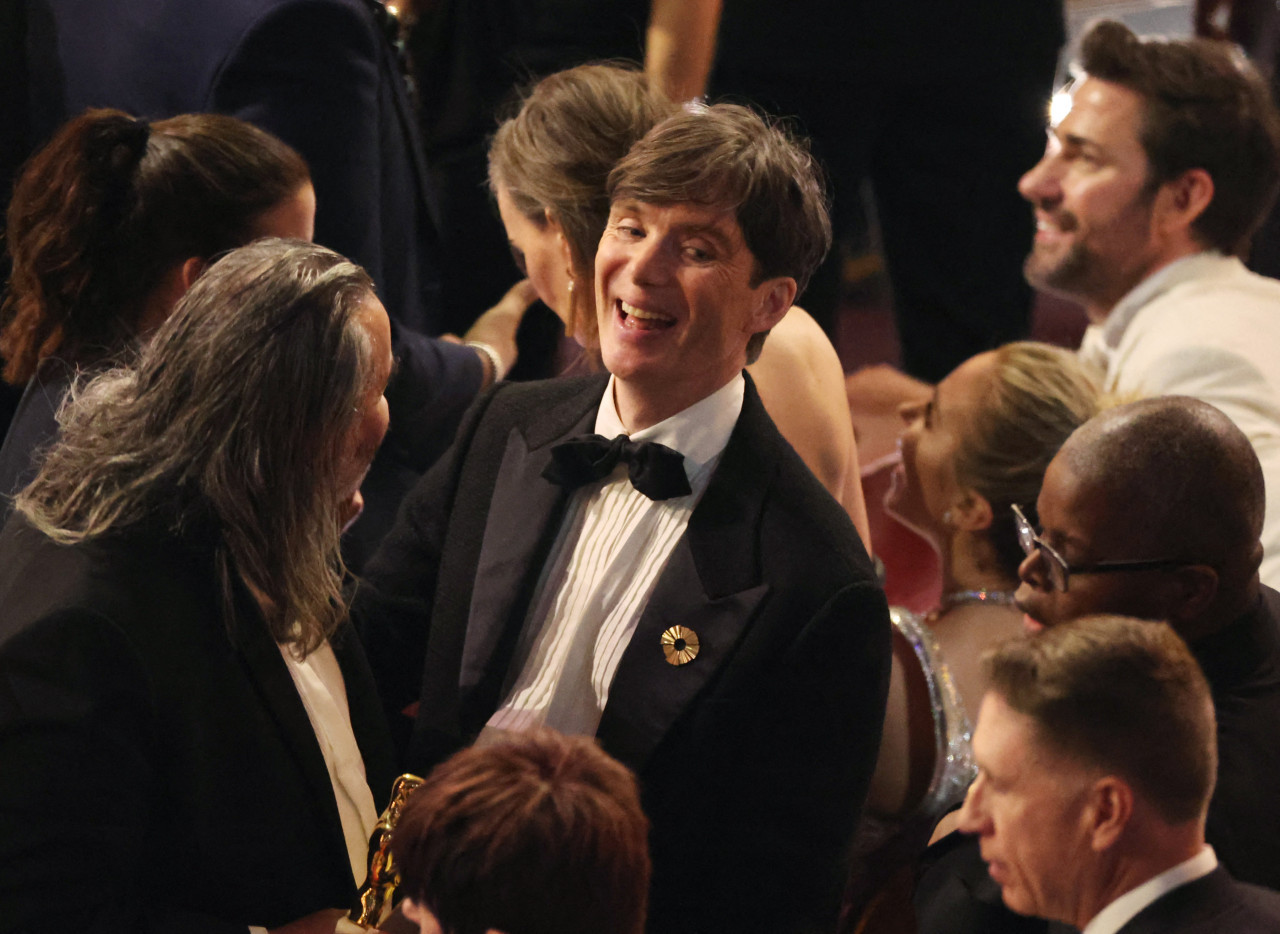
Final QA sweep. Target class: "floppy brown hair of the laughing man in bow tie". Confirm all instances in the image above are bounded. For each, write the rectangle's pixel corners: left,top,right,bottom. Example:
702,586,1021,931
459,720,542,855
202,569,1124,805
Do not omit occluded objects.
609,104,831,361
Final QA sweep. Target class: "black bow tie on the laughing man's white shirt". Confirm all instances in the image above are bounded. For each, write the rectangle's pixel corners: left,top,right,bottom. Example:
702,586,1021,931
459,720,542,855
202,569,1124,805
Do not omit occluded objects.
543,435,692,499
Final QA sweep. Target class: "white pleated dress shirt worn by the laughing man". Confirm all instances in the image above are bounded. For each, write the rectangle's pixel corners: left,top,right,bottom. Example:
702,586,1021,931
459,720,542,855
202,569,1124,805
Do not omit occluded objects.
480,375,746,742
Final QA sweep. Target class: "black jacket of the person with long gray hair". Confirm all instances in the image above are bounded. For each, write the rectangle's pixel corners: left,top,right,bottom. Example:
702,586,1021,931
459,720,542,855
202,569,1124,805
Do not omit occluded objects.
0,516,393,934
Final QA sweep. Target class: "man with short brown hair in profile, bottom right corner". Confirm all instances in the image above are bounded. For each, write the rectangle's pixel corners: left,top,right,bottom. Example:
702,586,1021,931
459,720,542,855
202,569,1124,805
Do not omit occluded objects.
960,617,1280,934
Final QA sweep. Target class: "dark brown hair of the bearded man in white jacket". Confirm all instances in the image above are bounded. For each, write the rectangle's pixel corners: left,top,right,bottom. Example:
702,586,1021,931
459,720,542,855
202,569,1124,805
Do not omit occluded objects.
1080,20,1280,253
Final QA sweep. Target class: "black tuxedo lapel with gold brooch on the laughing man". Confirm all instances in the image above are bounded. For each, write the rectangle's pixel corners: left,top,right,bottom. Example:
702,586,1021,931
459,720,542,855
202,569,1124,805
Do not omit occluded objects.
596,380,774,769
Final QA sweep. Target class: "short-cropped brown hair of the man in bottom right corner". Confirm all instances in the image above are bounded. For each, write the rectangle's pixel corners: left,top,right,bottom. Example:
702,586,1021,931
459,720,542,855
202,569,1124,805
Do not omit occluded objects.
986,615,1217,824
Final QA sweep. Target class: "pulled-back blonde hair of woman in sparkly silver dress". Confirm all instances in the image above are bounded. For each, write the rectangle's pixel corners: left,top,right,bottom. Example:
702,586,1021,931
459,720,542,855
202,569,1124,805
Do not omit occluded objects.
955,340,1103,577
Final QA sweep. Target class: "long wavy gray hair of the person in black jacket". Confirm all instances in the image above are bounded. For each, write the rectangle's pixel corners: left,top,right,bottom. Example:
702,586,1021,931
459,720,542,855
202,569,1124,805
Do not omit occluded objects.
15,239,374,651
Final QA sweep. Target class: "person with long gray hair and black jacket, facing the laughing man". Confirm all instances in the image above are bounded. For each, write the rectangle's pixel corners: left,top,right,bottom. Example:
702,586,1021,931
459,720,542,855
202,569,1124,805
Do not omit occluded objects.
0,239,392,934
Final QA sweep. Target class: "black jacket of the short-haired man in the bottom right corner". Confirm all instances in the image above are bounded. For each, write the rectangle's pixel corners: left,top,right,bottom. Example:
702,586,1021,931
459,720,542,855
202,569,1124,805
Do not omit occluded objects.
1119,867,1280,934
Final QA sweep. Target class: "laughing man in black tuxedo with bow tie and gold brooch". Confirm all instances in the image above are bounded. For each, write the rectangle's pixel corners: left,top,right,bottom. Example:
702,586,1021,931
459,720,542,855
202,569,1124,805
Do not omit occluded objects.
355,106,888,931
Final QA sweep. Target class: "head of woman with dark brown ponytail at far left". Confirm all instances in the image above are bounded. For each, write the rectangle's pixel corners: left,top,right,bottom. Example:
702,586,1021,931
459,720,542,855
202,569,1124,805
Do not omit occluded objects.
0,110,315,514
